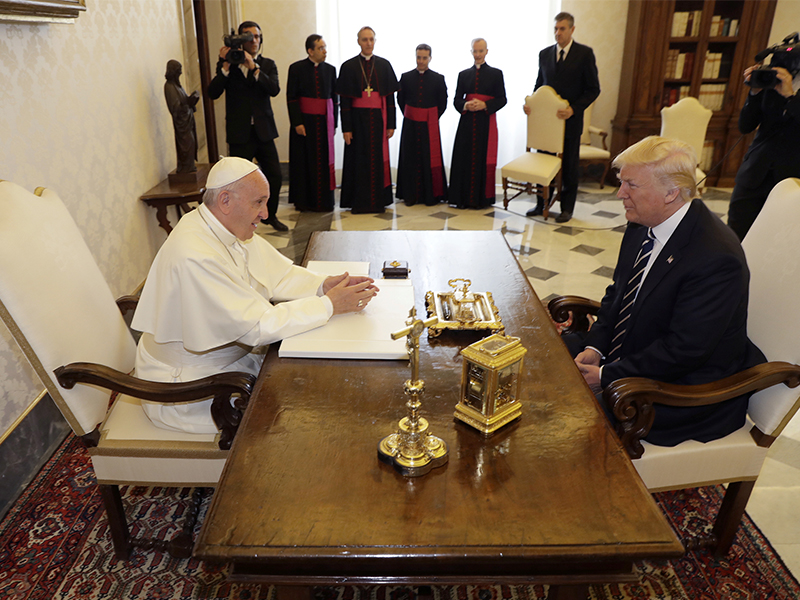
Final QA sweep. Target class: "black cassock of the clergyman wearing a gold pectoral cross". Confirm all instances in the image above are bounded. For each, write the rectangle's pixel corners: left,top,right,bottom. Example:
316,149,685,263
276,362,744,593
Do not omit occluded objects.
336,55,397,213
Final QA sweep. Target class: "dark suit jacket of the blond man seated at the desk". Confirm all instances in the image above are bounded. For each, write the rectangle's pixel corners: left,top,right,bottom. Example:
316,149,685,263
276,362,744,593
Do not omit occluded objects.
585,200,766,446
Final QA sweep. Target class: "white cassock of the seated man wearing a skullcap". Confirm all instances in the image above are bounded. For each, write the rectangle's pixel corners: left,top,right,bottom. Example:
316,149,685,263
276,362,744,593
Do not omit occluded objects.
131,205,333,433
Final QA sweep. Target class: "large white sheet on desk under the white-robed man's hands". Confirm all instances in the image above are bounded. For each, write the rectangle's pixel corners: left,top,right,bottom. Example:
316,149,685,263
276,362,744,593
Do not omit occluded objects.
278,278,414,360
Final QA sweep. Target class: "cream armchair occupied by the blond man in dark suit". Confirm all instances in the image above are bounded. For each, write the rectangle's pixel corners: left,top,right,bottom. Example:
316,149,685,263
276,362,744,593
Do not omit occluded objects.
549,179,800,556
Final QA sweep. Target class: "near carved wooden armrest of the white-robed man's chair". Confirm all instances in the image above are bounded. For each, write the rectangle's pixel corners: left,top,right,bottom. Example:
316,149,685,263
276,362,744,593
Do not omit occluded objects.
55,363,256,450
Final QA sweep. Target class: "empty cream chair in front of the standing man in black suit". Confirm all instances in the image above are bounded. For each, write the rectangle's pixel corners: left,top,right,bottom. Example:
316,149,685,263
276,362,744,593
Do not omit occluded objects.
500,85,569,219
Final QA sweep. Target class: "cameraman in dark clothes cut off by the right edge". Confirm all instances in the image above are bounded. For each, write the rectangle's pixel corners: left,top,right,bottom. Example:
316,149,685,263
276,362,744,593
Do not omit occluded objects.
728,33,800,240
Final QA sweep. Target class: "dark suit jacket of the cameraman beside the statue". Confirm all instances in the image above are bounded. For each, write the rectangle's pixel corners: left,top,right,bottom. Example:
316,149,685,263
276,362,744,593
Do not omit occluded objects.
208,55,281,144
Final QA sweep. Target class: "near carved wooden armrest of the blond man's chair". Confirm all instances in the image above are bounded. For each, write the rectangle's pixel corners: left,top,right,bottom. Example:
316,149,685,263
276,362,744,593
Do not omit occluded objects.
603,362,800,458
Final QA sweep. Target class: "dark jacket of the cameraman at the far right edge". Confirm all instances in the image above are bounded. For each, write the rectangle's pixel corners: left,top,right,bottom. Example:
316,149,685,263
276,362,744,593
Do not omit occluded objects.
736,90,800,188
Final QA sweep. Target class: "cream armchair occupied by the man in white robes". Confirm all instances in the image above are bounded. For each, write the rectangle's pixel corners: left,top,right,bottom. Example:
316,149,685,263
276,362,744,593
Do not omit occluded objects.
0,181,254,559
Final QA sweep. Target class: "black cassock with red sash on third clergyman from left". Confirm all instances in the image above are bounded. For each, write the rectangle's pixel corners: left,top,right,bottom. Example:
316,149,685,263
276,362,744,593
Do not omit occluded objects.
395,69,447,206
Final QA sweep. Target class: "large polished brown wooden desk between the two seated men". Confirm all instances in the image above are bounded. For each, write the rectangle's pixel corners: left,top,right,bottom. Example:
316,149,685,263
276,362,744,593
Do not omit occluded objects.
195,231,683,598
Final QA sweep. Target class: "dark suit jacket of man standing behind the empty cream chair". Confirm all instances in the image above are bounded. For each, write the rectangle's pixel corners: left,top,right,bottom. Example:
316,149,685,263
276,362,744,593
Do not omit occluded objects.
533,41,600,137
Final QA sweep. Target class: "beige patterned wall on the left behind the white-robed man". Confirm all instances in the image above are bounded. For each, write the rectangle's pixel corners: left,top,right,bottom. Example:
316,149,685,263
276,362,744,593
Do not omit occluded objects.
0,0,184,436
